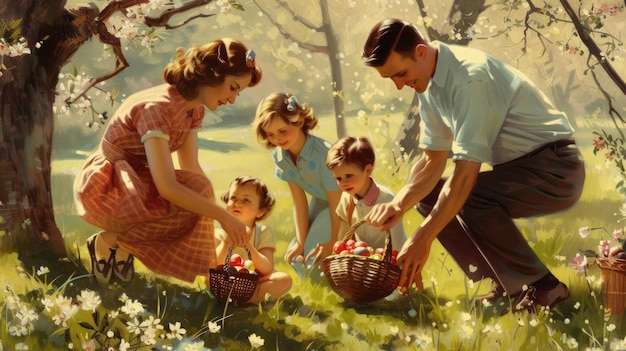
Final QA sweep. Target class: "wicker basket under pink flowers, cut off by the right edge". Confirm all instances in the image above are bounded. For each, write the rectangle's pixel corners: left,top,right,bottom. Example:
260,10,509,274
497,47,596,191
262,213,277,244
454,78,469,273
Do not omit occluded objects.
596,257,626,317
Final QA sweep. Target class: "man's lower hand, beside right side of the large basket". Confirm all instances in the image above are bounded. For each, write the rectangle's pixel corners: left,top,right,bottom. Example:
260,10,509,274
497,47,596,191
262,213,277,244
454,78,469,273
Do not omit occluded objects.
396,231,432,292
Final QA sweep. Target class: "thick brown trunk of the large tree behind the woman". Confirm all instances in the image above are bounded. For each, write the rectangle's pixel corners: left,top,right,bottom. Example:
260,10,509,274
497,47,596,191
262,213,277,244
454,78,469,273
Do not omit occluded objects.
0,0,97,257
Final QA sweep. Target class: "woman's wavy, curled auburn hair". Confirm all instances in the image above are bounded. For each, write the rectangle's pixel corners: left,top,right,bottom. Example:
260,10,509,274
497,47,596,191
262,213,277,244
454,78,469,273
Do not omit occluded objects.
163,38,263,100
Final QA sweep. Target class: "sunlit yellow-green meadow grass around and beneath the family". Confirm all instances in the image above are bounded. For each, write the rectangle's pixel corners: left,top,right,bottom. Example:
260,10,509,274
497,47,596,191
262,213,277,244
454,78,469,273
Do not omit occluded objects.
0,115,626,350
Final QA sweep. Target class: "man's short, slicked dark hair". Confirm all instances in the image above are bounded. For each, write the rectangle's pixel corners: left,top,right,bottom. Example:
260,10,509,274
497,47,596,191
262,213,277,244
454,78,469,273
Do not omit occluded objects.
361,18,426,67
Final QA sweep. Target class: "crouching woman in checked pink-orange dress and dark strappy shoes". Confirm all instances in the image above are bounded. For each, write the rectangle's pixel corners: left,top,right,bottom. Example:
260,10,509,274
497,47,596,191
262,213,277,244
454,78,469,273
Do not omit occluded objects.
74,38,262,284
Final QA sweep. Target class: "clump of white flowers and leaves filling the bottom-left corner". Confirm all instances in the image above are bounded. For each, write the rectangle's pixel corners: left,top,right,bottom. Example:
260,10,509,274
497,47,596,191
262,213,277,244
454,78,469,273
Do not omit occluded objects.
3,282,186,351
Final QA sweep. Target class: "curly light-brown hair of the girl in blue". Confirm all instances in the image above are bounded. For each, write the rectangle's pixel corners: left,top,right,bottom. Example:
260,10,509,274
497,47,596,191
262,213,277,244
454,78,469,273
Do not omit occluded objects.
254,93,317,149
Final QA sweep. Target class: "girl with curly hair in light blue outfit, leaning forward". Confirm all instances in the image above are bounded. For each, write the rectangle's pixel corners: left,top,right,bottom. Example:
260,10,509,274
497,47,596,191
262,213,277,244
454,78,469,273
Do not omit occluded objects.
254,93,341,276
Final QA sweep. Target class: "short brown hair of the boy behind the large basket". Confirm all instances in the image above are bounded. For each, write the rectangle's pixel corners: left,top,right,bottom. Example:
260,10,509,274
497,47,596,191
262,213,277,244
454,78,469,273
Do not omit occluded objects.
326,137,376,169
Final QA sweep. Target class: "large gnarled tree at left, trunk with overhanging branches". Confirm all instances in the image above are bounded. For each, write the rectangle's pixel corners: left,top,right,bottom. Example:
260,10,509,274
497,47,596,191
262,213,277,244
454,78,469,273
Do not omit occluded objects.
0,0,242,257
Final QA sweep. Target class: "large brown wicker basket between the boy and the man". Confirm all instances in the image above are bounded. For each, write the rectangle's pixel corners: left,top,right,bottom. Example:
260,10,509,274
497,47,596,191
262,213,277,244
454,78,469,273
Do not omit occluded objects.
324,221,401,304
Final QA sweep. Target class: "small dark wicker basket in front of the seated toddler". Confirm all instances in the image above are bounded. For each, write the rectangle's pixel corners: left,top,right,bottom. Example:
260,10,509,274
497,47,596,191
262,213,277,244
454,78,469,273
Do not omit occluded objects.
209,245,259,305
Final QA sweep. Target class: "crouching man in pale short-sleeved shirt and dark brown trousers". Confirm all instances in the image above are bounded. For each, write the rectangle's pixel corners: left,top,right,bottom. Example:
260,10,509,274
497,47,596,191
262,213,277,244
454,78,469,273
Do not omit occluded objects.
363,19,585,310
